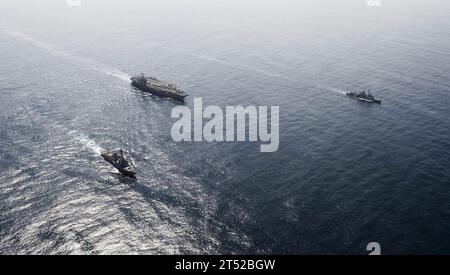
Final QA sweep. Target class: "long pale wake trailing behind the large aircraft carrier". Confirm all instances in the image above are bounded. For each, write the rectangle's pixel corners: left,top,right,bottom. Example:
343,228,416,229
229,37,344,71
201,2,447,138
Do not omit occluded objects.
4,30,130,81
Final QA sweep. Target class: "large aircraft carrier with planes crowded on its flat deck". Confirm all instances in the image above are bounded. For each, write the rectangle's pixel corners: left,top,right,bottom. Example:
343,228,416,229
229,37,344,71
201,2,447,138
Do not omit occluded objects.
130,74,188,102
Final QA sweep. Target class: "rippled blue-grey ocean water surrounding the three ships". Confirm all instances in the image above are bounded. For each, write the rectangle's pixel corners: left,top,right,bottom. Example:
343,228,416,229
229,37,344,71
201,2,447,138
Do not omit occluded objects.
0,0,450,254
